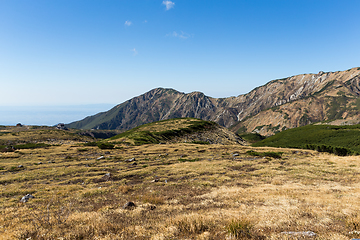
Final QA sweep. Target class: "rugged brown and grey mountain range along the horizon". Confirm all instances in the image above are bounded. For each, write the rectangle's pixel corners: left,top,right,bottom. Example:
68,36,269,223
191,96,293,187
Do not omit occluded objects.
66,67,360,135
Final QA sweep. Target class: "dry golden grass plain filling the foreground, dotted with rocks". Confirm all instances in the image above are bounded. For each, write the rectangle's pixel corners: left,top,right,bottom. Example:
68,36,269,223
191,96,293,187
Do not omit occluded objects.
0,130,360,240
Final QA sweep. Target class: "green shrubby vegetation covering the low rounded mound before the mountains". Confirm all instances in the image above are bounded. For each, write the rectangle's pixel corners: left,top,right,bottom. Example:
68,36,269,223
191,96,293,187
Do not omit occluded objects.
110,118,217,145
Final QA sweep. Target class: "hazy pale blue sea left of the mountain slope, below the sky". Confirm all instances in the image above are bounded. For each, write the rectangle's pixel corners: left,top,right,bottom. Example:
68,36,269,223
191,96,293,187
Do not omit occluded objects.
0,104,115,126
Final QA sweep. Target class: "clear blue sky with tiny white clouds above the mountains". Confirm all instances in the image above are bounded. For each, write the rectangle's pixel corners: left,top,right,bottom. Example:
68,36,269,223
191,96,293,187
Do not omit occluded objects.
0,0,360,106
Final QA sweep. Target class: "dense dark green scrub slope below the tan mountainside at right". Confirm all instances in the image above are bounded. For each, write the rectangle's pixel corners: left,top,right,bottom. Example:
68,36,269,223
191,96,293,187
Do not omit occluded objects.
252,125,360,156
